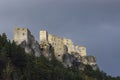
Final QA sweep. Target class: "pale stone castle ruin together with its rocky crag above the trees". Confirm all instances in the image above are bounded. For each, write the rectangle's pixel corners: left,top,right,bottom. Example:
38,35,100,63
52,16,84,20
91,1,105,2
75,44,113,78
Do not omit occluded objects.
14,28,97,69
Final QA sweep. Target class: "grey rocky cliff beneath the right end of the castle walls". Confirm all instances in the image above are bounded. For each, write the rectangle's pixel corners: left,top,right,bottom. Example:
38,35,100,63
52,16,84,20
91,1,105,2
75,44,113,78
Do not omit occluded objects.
63,53,98,70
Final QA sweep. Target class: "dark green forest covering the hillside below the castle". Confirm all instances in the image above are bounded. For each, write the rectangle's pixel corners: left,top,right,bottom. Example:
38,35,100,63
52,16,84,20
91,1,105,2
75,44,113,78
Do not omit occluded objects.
0,33,120,80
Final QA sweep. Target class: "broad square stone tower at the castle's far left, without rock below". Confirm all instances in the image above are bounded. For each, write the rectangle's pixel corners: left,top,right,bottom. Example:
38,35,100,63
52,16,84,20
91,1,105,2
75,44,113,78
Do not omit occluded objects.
14,28,30,44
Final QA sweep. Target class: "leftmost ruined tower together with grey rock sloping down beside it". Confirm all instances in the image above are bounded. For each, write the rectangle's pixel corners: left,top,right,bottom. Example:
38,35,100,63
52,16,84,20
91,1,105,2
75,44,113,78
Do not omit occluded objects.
13,28,41,57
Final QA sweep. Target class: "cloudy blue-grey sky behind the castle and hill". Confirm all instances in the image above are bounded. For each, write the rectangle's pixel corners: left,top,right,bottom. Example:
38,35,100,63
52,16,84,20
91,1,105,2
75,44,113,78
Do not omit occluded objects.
0,0,120,76
